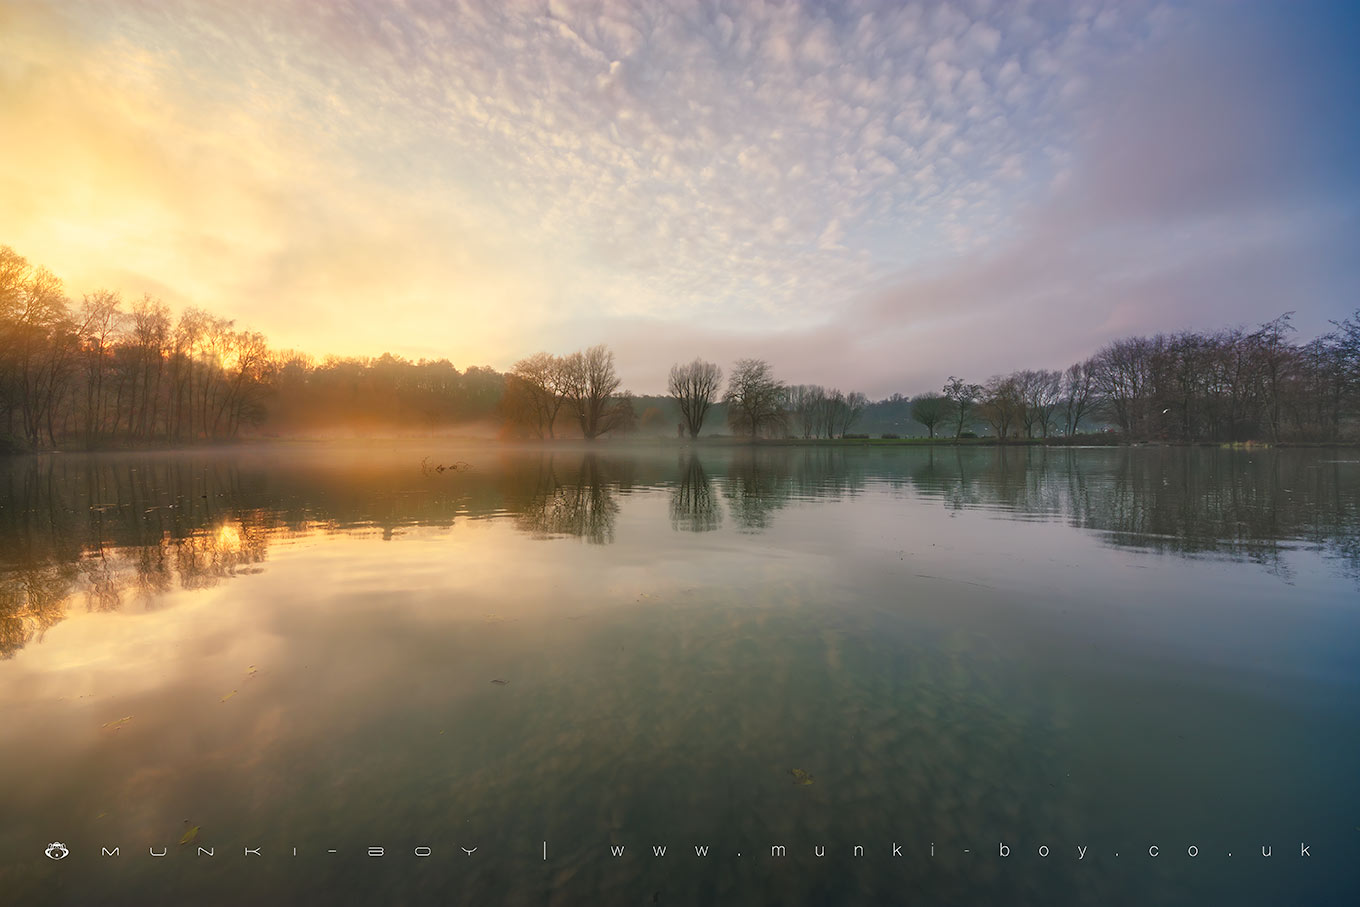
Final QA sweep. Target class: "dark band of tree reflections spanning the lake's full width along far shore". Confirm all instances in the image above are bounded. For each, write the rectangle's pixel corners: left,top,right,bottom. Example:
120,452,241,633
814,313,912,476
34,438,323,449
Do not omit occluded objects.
0,447,1360,658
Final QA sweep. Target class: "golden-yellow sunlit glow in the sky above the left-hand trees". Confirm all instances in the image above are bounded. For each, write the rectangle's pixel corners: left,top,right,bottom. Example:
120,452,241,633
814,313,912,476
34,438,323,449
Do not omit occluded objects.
0,7,552,364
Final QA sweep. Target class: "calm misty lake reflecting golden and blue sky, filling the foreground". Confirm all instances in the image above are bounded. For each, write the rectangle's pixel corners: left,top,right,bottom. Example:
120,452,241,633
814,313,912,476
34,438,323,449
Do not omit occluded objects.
0,442,1360,904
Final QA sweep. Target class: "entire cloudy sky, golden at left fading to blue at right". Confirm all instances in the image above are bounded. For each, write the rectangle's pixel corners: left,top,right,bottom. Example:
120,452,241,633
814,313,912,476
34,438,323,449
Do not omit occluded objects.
0,0,1360,397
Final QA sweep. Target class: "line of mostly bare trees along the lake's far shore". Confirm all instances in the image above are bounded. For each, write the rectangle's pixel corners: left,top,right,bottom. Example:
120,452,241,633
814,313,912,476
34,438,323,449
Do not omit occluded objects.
0,246,1360,451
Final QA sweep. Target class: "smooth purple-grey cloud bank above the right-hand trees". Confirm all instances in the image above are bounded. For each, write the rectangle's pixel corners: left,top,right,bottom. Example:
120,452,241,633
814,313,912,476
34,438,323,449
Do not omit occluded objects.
851,2,1360,394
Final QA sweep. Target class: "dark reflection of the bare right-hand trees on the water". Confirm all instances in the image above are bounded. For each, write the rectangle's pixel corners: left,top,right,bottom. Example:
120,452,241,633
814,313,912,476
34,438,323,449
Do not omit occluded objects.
911,447,1360,575
